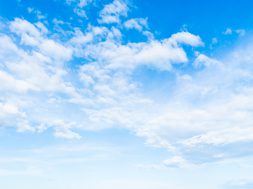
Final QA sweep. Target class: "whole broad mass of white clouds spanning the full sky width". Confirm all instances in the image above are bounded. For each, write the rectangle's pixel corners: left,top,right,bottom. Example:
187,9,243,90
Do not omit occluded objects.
0,0,253,166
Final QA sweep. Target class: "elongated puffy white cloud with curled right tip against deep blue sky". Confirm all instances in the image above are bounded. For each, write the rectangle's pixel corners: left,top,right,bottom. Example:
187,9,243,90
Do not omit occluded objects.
77,33,202,70
